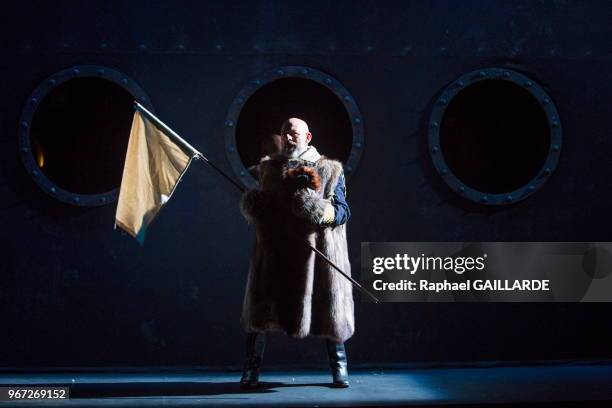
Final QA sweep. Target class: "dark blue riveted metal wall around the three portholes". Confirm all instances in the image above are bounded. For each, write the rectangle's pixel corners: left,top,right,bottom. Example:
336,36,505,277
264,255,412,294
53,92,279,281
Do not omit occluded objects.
0,1,612,367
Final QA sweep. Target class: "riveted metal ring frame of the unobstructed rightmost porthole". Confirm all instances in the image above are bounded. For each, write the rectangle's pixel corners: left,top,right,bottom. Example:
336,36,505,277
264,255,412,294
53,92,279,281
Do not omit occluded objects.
428,68,562,206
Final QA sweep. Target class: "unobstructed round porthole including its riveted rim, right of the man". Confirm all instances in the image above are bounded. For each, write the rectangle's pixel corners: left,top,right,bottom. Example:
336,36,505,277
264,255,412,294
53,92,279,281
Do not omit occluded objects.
429,68,561,205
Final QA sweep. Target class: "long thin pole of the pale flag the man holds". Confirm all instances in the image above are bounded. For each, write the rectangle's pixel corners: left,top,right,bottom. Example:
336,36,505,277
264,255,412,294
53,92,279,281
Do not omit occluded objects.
134,101,378,303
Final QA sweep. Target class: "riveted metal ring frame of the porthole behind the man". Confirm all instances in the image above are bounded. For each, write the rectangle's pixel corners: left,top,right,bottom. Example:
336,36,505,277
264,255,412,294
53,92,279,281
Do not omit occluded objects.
224,65,364,188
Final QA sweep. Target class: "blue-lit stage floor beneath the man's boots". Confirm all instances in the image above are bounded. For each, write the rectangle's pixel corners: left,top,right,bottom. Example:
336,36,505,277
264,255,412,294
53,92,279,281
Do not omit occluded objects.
0,363,612,407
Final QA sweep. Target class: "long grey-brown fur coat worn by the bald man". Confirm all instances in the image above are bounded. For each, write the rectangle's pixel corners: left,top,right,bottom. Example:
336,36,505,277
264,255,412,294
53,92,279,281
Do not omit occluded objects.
240,156,355,342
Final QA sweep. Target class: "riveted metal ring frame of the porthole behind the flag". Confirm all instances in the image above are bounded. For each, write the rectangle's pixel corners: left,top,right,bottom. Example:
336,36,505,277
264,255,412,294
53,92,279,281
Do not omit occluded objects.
18,65,155,207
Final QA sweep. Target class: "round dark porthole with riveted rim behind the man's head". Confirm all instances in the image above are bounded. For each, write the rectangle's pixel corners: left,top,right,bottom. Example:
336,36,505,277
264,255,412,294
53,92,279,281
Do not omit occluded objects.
225,66,363,187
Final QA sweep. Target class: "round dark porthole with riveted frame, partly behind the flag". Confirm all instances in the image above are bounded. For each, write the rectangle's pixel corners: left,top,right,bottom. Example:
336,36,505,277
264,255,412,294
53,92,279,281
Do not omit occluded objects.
19,66,149,206
